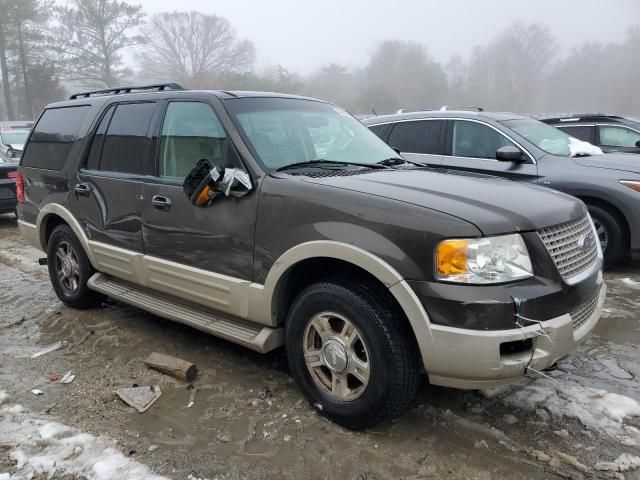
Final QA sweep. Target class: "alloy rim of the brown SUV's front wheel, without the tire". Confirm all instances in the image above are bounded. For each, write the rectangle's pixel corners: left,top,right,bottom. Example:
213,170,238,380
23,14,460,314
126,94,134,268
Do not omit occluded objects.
303,312,371,401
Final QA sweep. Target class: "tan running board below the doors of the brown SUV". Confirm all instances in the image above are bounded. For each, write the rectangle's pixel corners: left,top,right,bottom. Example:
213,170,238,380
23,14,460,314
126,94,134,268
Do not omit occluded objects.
88,273,284,353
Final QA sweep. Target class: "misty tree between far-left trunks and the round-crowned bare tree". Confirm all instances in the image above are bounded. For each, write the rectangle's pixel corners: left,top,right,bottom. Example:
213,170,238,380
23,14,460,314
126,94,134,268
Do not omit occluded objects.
53,0,144,86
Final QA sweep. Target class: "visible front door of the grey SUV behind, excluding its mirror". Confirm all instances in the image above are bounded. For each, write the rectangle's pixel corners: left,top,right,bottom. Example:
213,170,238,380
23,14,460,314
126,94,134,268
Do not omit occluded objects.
442,120,538,182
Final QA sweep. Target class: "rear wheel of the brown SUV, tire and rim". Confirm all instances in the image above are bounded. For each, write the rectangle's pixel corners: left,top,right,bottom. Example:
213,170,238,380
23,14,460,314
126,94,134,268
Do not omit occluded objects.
47,225,103,308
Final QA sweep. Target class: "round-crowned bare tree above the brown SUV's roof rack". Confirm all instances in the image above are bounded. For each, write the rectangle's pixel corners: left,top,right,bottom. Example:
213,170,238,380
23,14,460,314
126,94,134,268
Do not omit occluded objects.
140,12,255,88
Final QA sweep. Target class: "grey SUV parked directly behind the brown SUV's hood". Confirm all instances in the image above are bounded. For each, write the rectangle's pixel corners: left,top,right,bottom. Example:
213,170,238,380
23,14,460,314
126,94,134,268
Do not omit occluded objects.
363,111,640,264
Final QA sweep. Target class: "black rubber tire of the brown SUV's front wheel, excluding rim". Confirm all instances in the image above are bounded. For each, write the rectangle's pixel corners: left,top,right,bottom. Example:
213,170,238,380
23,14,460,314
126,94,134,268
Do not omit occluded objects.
285,280,421,430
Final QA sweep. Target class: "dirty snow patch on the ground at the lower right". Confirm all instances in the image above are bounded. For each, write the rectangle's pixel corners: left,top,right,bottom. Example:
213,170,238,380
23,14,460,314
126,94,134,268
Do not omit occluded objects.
484,378,640,446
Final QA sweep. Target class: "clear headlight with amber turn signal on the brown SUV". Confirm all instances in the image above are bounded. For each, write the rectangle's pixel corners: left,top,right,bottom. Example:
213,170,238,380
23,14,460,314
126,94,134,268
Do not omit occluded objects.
435,233,533,284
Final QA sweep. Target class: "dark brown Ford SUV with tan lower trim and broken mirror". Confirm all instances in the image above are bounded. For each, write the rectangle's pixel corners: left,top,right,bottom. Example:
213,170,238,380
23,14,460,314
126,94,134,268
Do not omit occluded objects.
17,85,606,428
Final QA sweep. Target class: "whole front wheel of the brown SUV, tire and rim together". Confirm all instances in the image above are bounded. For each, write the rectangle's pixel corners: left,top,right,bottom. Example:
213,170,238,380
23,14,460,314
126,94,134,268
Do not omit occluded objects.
285,280,421,430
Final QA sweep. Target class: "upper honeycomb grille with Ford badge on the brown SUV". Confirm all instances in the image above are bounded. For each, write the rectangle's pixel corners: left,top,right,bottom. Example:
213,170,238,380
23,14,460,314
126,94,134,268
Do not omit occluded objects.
538,216,598,281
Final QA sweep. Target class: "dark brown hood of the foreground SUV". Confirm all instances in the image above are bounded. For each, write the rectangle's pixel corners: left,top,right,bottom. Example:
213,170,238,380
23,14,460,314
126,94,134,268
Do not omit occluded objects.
304,169,586,235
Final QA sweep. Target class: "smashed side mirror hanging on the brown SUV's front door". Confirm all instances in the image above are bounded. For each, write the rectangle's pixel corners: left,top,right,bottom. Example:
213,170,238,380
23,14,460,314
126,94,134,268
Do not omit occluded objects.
182,158,253,207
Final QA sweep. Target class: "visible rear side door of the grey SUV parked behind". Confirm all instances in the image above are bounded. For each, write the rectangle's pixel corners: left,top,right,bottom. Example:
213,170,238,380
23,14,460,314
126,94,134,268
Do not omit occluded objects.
387,119,446,166
